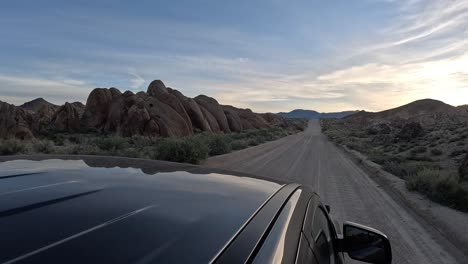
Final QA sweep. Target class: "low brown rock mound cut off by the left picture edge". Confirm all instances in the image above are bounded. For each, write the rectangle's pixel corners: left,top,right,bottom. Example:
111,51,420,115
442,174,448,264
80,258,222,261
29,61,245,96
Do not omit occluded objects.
0,101,38,139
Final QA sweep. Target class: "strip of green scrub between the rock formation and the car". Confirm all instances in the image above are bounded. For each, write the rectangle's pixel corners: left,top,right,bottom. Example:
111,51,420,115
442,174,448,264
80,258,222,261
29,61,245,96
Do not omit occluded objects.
0,122,306,163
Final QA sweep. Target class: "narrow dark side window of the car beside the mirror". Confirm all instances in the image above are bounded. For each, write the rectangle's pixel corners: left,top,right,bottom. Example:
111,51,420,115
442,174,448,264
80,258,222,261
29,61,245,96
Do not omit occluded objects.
312,207,334,263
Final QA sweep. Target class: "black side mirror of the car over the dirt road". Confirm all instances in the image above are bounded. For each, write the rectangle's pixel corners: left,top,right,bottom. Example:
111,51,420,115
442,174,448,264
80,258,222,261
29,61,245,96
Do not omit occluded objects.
343,222,392,264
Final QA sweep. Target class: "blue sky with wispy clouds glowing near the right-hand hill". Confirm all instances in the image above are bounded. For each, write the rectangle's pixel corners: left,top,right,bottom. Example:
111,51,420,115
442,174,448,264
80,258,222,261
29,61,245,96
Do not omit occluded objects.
0,0,468,112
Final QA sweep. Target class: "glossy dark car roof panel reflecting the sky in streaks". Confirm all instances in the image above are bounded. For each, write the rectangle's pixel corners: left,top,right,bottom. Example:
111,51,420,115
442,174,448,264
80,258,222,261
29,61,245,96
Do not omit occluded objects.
0,158,282,263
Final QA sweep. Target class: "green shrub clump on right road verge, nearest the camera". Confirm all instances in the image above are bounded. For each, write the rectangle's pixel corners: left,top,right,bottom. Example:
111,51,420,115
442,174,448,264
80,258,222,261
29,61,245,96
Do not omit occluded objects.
406,169,468,212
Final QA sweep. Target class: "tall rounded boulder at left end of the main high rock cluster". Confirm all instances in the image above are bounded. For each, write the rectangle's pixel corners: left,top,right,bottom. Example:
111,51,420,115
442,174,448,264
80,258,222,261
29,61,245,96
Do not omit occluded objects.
81,88,122,130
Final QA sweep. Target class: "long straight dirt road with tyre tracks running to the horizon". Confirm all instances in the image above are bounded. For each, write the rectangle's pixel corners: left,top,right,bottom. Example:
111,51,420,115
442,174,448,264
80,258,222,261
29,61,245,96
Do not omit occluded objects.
204,120,463,264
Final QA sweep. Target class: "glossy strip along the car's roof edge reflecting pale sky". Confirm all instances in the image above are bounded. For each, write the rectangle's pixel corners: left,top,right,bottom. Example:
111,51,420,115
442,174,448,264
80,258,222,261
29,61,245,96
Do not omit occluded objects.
254,190,302,263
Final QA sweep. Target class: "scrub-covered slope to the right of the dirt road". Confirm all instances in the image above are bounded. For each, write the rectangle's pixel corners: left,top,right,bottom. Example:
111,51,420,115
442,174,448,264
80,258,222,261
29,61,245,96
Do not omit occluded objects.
321,119,468,211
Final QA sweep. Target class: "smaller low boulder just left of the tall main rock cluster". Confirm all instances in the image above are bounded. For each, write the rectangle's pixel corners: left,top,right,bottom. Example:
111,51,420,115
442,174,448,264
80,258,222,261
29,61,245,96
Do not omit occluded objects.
50,102,83,132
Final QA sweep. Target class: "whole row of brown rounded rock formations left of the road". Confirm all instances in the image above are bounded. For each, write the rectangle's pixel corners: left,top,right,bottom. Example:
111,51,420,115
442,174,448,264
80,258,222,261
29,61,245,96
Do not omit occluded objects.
0,80,287,138
